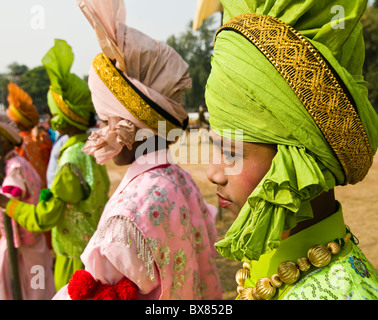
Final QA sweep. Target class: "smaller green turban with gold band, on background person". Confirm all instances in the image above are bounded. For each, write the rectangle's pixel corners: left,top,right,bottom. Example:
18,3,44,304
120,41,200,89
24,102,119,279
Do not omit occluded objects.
42,39,95,130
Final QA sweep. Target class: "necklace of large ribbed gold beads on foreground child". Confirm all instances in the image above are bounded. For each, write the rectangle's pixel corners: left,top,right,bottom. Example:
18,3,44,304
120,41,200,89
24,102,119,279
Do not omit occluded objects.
235,233,352,300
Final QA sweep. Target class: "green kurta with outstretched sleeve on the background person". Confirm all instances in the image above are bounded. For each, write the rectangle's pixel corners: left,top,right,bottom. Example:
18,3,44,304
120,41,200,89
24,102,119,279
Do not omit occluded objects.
6,134,110,290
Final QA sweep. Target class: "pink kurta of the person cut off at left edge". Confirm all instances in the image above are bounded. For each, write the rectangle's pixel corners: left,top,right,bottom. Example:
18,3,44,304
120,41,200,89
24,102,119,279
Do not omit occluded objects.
0,151,55,300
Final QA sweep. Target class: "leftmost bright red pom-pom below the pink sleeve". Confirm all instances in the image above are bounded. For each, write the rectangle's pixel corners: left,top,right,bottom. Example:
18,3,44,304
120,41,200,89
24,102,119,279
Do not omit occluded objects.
67,270,98,300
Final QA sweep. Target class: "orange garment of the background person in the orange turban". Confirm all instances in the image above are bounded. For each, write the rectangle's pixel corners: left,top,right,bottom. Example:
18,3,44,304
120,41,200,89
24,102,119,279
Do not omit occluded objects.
16,131,47,188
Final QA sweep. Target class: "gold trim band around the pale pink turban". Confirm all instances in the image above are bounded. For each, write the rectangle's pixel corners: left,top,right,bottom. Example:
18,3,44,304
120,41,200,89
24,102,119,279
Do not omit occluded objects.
92,53,181,132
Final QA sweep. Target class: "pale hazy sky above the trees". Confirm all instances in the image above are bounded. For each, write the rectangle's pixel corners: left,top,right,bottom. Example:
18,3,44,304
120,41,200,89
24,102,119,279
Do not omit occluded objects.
0,0,211,77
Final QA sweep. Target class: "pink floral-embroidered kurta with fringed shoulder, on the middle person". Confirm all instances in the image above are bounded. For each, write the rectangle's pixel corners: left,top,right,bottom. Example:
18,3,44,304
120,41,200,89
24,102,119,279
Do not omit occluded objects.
54,150,222,299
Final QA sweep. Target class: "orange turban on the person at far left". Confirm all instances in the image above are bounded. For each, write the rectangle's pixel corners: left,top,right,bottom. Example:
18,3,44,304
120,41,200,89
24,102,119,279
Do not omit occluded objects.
7,83,39,129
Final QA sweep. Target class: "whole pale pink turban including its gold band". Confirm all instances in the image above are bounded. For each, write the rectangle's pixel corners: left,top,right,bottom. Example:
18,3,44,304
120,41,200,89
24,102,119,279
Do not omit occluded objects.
77,0,192,164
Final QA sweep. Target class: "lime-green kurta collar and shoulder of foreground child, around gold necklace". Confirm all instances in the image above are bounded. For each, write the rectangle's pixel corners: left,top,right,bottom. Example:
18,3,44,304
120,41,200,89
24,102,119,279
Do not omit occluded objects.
244,204,378,300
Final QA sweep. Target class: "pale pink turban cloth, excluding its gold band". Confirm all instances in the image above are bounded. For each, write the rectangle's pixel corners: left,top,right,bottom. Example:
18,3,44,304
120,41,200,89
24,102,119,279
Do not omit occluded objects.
77,0,192,164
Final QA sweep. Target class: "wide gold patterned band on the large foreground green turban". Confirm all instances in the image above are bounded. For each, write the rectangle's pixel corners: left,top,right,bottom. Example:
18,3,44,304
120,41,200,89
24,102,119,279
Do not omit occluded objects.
217,13,373,184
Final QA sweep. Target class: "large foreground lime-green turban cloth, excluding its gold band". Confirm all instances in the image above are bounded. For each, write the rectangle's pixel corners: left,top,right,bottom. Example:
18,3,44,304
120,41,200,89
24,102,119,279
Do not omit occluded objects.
205,0,378,261
